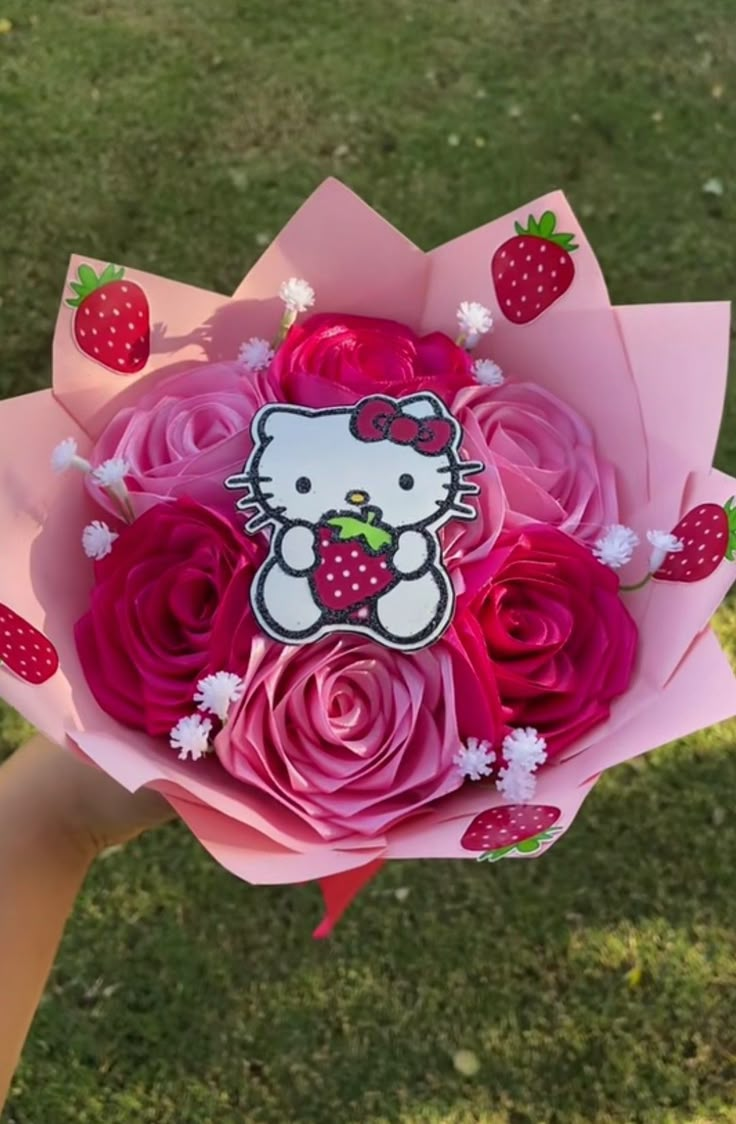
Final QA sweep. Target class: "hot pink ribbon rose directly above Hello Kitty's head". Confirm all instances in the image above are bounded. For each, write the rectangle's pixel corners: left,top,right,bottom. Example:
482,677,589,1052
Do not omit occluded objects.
271,312,473,408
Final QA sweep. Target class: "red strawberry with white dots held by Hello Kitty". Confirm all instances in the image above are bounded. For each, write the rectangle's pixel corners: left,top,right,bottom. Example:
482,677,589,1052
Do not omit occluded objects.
311,511,398,618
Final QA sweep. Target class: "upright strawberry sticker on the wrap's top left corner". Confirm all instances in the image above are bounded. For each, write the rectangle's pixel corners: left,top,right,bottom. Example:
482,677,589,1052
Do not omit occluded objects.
66,264,151,374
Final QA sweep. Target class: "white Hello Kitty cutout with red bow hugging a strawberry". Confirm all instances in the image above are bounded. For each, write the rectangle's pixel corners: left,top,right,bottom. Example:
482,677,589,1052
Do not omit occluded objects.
225,393,483,652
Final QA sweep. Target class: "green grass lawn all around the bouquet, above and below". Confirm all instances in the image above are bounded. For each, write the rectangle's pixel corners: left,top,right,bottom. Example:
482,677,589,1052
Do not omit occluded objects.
0,0,736,1124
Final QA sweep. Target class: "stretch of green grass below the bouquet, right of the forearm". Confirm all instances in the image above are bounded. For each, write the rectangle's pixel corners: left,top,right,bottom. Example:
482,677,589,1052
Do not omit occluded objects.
8,729,736,1124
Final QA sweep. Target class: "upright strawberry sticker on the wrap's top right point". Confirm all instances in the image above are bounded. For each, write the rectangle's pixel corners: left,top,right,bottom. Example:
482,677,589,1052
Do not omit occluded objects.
491,211,578,324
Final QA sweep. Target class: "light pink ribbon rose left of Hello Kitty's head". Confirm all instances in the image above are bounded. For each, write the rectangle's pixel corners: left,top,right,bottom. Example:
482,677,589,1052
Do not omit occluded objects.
90,363,278,519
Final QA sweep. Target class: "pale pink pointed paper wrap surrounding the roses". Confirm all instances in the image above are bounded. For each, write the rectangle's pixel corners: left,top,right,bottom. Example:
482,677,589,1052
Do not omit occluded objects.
0,180,736,935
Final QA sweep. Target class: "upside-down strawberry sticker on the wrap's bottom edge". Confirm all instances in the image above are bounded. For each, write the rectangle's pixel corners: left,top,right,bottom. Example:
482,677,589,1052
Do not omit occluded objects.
460,804,562,862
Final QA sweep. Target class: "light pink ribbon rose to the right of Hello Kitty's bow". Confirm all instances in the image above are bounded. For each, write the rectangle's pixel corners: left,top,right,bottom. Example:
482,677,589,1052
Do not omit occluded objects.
451,382,618,546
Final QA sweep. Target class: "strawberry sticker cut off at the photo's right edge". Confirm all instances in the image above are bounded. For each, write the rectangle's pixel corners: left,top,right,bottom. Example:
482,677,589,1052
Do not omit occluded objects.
652,496,736,582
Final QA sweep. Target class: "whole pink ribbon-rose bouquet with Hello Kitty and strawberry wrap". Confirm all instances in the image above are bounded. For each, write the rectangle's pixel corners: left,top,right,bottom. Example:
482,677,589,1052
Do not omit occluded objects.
0,181,736,935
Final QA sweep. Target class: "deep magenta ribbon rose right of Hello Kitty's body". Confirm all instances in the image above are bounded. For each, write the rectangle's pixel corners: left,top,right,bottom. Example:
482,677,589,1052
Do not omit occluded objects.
463,526,637,758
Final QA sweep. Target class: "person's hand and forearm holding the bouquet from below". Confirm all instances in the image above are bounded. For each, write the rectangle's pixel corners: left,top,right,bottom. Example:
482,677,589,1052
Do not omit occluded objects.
0,735,172,1112
